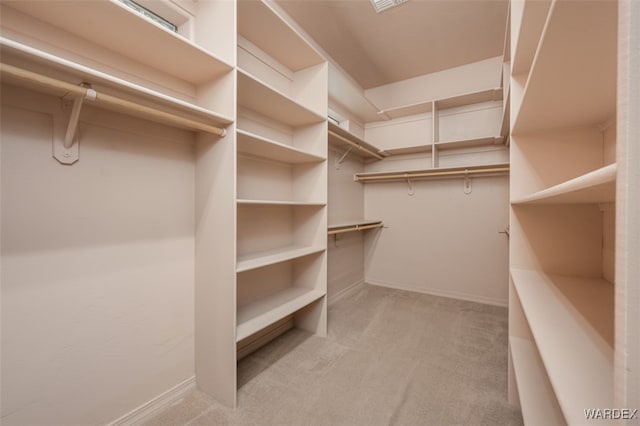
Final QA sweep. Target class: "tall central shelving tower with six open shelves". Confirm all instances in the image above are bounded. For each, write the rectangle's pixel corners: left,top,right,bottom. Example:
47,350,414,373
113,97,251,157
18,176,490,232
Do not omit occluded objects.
234,1,328,402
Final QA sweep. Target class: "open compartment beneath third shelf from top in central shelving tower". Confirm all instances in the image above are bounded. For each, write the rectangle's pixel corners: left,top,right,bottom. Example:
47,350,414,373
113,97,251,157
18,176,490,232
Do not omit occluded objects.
237,154,327,205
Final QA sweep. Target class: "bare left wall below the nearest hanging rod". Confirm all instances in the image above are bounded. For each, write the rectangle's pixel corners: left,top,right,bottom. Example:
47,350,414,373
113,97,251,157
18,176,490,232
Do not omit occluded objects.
1,86,194,425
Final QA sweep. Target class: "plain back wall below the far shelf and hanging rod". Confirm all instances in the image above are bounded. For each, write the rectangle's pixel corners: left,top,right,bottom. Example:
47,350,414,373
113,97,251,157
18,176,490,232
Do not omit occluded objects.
365,176,509,305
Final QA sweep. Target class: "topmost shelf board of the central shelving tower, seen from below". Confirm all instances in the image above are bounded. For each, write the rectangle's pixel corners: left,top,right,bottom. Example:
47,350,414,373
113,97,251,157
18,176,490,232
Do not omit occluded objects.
238,0,325,72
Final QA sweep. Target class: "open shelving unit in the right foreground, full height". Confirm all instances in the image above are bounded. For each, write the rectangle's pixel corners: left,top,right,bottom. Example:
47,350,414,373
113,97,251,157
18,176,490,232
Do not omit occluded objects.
509,0,636,424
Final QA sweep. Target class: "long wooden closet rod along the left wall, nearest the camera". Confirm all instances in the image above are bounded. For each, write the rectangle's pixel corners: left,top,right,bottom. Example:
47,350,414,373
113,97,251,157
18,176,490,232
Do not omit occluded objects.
0,63,226,137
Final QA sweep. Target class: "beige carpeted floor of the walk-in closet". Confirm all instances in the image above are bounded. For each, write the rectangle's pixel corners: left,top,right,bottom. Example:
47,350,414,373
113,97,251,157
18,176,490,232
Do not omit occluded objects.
146,285,522,426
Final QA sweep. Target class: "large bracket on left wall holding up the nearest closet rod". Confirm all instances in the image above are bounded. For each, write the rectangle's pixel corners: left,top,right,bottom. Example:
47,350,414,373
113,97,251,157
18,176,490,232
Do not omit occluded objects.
52,85,98,164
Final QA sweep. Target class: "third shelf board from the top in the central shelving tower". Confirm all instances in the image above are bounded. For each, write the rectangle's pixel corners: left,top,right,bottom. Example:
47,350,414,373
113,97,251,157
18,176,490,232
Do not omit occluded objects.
236,129,326,164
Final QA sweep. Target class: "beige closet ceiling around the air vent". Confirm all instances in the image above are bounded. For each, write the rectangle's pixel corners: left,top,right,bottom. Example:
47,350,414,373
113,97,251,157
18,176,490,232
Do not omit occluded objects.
277,0,508,89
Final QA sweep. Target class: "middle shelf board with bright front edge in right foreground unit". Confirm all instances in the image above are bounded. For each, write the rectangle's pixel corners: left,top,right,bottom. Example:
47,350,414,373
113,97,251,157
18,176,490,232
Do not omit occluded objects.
512,164,617,204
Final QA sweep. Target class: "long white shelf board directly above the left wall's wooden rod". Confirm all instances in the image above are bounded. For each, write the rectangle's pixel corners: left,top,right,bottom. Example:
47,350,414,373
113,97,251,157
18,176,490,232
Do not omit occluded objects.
0,37,233,126
